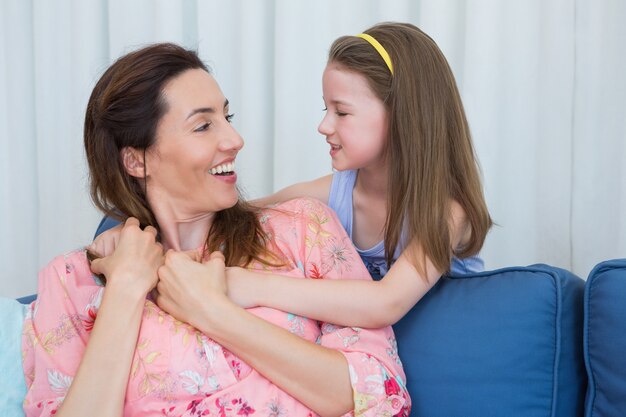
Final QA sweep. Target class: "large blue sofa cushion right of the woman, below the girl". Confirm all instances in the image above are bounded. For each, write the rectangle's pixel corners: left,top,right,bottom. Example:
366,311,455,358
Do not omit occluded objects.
394,265,586,417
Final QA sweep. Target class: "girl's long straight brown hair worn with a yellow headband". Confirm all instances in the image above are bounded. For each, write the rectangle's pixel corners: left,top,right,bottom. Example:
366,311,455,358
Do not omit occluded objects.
328,23,492,273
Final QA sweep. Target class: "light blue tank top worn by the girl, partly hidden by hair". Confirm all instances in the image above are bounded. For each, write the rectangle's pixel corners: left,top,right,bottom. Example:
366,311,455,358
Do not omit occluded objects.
328,170,485,280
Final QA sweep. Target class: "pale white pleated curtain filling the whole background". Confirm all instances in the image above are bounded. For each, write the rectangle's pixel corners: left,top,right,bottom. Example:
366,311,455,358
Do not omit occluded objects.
0,0,626,297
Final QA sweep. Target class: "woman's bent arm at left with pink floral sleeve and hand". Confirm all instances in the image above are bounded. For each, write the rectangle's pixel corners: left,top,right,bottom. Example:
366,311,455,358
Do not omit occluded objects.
25,219,162,417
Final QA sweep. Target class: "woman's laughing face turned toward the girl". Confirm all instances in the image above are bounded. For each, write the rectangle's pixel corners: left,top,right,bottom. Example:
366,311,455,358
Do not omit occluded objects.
145,69,243,220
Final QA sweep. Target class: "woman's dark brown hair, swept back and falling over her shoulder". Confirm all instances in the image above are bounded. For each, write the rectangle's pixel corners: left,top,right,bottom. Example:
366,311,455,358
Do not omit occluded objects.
84,43,271,266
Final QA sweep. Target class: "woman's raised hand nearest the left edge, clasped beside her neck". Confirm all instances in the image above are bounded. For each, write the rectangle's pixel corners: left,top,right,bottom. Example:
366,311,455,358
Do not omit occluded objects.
91,217,163,297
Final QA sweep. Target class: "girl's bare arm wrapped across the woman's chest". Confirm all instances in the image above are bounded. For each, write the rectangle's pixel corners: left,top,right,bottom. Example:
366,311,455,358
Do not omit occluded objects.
227,202,469,328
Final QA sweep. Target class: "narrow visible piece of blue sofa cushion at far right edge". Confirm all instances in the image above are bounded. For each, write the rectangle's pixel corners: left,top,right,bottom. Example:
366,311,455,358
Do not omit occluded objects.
584,259,626,417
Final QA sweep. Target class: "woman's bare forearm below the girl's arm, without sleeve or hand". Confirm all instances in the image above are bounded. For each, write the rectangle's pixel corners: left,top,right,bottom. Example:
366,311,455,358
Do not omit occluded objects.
198,297,354,416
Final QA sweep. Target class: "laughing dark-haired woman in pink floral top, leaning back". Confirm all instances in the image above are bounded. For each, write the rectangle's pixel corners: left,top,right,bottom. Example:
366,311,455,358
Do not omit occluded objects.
23,44,409,416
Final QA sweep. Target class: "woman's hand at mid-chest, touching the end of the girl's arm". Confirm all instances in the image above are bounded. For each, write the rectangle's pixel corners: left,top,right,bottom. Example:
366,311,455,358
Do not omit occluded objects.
156,250,227,328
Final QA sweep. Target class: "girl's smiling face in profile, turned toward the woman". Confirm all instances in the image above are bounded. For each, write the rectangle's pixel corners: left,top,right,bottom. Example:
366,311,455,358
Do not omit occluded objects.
317,62,387,171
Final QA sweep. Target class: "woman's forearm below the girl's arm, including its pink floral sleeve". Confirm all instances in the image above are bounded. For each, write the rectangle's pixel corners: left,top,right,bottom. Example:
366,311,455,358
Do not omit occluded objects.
196,286,410,417
